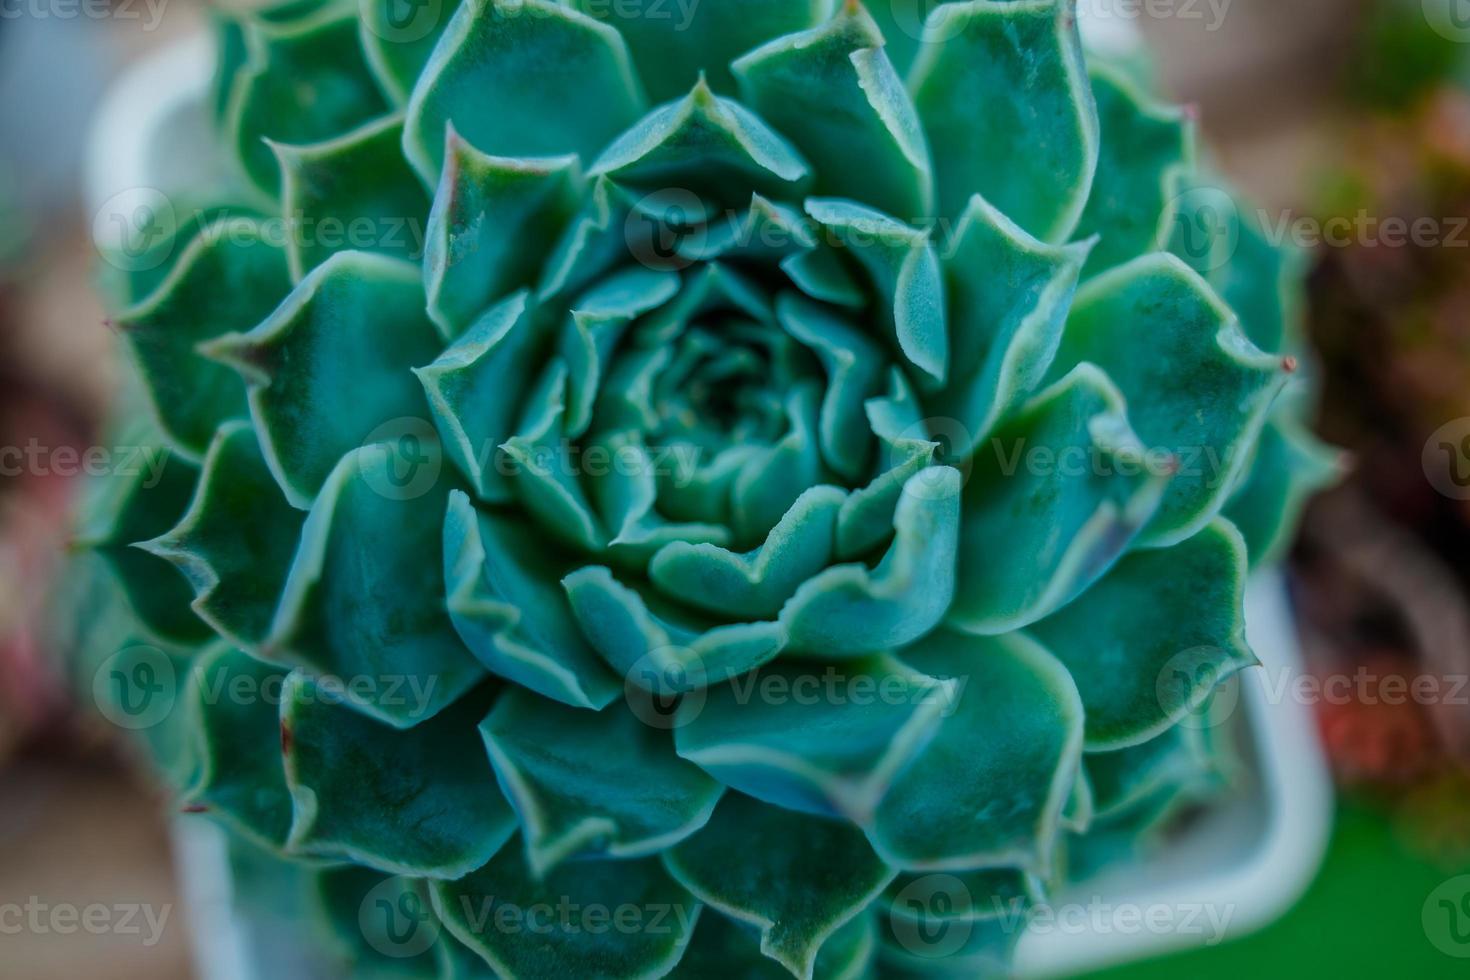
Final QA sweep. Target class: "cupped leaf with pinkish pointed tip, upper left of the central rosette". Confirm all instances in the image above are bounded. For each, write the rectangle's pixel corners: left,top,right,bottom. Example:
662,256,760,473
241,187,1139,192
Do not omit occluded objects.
423,126,585,339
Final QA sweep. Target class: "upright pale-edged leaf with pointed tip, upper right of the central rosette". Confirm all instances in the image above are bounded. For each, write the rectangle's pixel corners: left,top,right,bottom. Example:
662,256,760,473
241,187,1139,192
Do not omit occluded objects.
928,195,1091,460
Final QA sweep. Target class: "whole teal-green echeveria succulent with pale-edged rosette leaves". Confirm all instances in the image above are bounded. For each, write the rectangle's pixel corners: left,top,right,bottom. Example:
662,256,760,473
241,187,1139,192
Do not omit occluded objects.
82,0,1346,977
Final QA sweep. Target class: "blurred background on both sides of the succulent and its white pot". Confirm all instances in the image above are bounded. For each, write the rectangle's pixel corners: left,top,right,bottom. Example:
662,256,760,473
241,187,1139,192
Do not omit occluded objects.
0,0,1470,980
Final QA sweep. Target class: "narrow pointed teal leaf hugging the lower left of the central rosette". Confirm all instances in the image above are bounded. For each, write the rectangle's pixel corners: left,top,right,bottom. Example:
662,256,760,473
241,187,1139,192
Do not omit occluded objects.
444,491,622,710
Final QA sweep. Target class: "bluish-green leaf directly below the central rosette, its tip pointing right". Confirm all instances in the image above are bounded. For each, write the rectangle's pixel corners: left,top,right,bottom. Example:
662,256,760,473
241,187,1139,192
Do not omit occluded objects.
675,655,956,824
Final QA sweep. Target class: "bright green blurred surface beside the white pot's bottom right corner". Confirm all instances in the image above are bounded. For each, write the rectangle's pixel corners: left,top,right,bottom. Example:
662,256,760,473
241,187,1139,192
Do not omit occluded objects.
1088,802,1470,980
